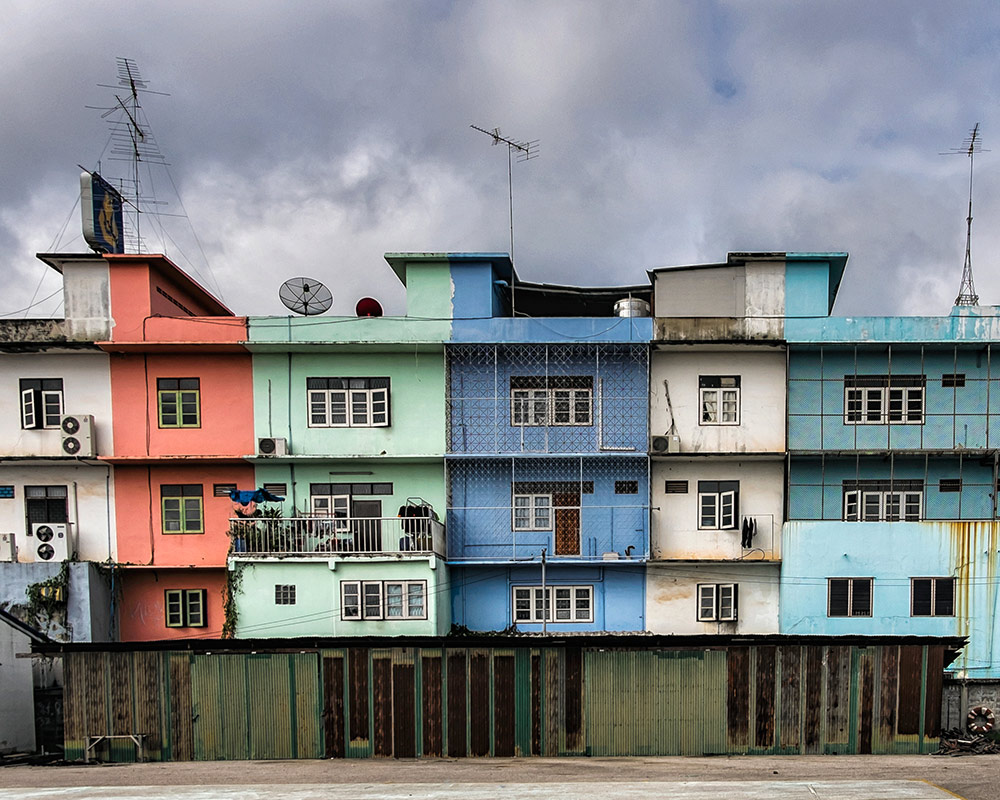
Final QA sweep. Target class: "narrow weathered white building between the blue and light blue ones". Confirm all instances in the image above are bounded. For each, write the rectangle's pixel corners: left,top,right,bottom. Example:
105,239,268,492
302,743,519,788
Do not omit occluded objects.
646,253,800,634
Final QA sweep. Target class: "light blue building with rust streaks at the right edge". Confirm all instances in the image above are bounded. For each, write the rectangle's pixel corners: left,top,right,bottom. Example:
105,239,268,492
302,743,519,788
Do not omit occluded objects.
780,306,1000,722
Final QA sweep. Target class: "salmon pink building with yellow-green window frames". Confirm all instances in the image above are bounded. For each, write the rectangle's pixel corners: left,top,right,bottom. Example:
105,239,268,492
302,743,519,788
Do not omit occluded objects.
98,255,254,641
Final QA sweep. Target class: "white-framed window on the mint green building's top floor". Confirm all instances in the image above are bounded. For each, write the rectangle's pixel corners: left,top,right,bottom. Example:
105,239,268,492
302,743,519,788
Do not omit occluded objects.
306,378,389,428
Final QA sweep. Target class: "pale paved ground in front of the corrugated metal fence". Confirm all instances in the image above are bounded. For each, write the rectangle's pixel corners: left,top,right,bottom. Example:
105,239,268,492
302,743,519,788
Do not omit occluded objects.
0,756,1000,800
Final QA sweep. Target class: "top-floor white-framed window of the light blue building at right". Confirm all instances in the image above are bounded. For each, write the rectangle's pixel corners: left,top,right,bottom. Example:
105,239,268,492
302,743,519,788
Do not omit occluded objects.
844,375,927,425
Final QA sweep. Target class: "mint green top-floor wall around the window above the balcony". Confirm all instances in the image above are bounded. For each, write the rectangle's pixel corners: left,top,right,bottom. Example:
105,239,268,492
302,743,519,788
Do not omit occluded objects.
253,345,445,458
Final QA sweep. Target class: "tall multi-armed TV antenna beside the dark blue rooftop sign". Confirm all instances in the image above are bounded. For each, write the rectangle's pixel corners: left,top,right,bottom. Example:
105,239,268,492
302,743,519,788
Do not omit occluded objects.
87,56,170,253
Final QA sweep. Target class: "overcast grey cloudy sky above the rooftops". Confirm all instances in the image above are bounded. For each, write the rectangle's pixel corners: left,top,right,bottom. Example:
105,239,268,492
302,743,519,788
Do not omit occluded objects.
0,0,1000,316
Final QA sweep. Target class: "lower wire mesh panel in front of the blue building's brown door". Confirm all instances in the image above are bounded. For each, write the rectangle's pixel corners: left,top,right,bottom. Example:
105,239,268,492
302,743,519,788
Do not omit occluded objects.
447,455,649,561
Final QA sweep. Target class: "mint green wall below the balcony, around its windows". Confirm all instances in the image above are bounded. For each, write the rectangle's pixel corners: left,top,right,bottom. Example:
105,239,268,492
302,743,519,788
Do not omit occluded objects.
230,557,451,639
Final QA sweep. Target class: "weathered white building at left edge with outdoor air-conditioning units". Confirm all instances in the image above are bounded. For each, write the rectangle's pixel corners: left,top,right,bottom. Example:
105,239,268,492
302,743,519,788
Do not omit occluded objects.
0,255,116,641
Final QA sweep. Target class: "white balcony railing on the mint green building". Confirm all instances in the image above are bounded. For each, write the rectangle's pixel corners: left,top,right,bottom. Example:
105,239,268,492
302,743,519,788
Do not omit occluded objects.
229,517,445,558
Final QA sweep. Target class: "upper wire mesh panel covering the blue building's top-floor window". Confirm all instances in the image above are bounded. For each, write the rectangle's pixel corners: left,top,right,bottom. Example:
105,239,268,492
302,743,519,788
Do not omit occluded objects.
448,344,649,454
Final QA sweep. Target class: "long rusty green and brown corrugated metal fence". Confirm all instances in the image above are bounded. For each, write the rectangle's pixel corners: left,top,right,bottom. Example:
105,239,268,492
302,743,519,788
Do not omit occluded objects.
63,643,946,761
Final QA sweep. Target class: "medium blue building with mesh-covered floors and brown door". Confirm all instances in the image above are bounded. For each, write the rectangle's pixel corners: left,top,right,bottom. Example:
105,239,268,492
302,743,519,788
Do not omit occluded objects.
434,255,652,632
